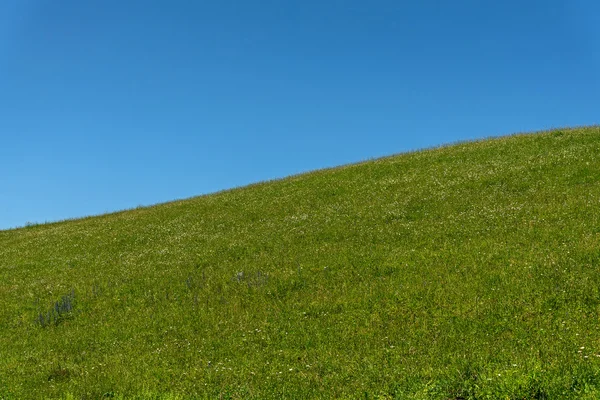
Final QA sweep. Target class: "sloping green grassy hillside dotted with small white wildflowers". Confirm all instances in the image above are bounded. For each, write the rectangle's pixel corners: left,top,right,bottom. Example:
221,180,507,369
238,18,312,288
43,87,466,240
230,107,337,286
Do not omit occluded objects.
0,127,600,400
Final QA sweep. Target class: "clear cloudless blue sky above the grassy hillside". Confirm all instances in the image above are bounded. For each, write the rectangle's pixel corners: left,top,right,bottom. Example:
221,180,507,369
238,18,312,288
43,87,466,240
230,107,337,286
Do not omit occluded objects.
0,0,600,229
